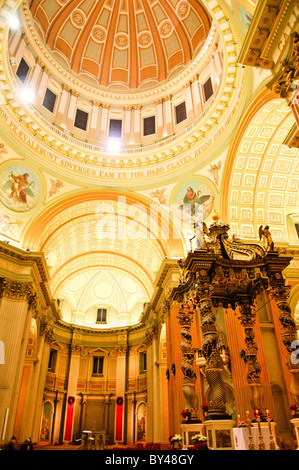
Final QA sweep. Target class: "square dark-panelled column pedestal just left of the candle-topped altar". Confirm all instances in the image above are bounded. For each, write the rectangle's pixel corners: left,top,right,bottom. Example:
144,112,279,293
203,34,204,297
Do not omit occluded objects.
205,419,234,450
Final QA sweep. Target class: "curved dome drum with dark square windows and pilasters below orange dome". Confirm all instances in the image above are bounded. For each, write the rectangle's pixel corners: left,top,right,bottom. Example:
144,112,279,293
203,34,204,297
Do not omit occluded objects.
9,18,223,152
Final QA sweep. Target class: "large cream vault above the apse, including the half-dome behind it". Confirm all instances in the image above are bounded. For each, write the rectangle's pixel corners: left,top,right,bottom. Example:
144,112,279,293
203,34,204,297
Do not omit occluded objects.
25,191,184,327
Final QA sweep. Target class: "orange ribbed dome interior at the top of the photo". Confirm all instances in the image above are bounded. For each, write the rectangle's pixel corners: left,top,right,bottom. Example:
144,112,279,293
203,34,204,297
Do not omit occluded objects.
30,0,210,89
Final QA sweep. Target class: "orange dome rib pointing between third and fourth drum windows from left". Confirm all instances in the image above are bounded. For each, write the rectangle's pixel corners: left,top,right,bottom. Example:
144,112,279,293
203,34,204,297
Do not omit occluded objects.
100,0,121,87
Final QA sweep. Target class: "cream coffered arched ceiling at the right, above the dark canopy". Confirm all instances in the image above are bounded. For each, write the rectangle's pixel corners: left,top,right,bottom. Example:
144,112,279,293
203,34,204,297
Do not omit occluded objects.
223,98,299,242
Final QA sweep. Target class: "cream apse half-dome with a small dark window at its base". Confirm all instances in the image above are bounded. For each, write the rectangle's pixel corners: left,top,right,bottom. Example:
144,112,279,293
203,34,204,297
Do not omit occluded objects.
58,263,149,328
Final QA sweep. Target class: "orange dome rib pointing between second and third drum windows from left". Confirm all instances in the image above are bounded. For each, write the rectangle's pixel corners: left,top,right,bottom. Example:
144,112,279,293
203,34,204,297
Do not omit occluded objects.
71,0,105,73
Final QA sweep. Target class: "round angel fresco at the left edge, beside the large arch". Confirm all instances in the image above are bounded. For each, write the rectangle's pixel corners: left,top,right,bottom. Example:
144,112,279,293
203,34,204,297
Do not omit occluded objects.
0,167,39,211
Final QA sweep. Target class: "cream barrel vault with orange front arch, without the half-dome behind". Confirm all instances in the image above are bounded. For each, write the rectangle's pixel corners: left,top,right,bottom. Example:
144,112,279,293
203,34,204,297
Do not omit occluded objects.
25,191,183,310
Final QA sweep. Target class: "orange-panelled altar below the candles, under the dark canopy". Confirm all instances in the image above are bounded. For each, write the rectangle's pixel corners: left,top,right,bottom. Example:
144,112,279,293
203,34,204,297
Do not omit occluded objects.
233,423,279,450
